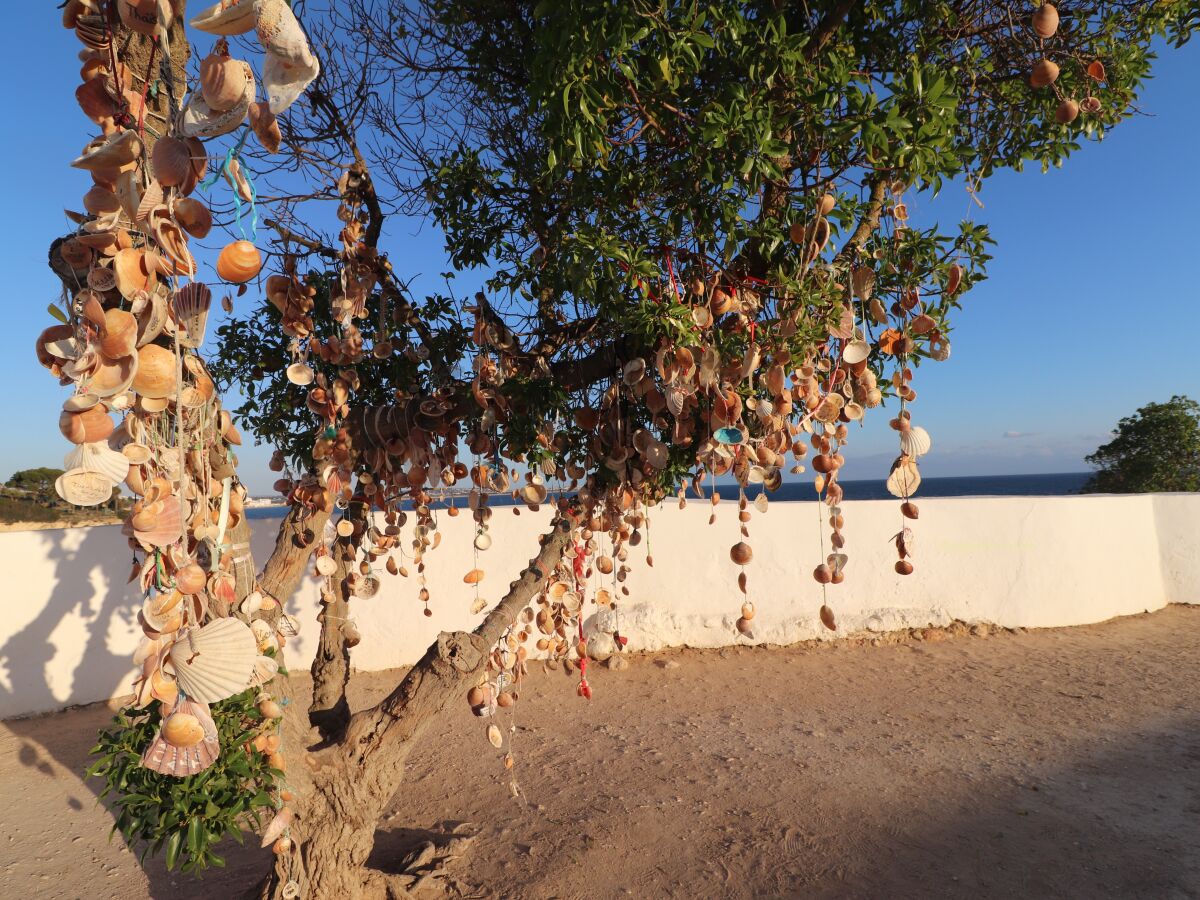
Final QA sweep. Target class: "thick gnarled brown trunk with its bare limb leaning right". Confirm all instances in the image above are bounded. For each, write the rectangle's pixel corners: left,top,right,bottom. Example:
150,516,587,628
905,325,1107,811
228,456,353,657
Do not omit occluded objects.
254,506,587,900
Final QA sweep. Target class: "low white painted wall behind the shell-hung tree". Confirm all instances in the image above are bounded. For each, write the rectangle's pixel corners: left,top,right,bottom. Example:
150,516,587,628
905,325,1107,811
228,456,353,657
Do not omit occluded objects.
0,494,1200,718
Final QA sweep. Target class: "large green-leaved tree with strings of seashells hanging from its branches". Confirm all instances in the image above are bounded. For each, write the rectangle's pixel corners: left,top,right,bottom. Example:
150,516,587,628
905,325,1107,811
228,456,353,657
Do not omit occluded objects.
40,0,1196,898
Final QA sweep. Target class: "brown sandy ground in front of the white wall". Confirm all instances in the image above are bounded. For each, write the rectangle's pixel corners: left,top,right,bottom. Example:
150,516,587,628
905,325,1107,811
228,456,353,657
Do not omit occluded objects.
0,606,1200,900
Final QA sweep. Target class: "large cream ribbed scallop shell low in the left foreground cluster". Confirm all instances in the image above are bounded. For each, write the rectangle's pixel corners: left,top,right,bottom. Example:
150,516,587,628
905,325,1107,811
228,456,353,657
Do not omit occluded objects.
170,618,258,703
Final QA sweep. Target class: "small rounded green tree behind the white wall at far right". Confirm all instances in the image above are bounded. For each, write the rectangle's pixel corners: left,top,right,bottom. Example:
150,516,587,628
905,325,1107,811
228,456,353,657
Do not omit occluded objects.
1084,395,1200,493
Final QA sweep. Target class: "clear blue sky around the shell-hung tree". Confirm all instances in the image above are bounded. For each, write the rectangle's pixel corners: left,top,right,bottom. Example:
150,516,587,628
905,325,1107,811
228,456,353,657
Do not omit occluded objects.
0,12,1200,492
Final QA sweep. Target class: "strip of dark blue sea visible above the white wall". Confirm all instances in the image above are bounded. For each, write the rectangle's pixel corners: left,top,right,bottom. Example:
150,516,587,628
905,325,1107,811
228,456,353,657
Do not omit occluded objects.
246,472,1092,518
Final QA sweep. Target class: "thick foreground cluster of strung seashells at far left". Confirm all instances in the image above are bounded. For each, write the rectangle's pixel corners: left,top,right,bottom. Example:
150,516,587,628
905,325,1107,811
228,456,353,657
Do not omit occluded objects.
46,0,316,864
